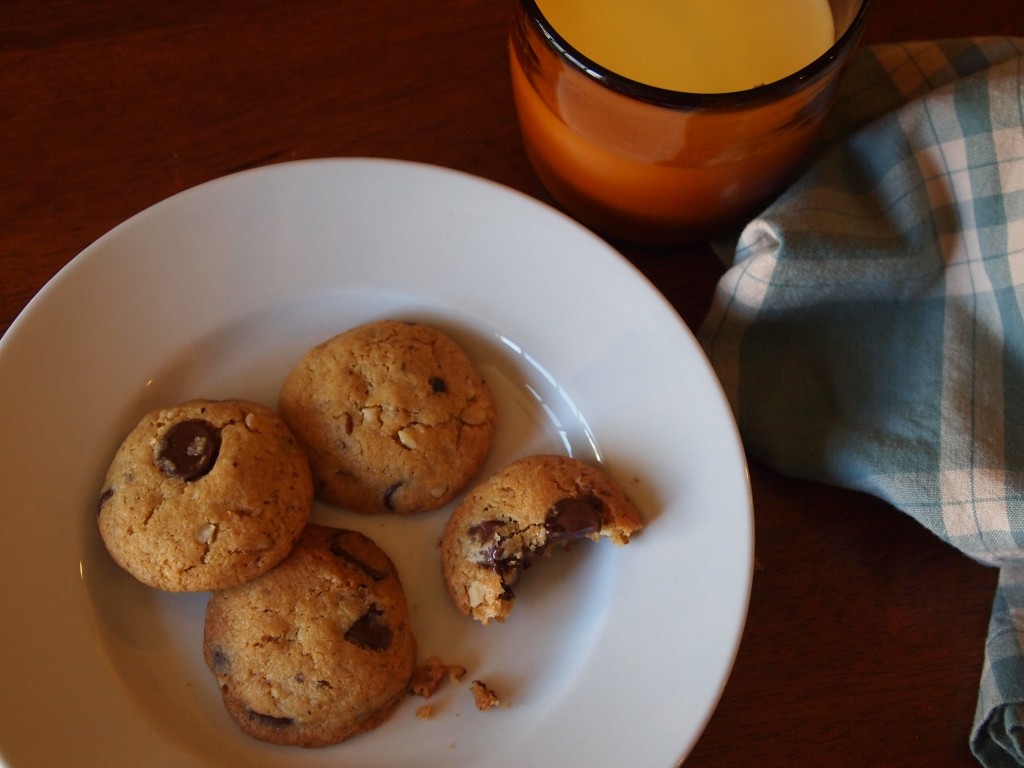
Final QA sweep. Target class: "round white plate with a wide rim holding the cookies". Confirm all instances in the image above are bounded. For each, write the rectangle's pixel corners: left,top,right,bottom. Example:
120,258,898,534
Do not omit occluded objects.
0,160,753,768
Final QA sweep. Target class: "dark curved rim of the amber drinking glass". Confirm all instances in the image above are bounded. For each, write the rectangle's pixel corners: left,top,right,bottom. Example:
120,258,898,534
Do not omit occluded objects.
518,0,871,109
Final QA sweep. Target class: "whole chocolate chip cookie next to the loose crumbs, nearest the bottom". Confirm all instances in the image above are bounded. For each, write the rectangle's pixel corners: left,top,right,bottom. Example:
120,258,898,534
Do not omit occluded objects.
203,524,416,746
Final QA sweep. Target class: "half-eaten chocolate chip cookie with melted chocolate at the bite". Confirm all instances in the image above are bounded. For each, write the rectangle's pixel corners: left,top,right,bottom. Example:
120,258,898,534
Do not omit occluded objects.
441,456,643,624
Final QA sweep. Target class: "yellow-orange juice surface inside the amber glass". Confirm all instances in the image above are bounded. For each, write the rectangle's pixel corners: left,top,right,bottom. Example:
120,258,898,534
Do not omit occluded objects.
537,0,836,93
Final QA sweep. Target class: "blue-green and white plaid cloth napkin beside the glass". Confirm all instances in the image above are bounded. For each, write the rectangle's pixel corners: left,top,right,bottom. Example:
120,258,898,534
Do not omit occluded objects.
698,38,1024,768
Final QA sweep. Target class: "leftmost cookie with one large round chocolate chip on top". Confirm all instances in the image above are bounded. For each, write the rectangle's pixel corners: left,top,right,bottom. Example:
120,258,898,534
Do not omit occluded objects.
98,399,313,592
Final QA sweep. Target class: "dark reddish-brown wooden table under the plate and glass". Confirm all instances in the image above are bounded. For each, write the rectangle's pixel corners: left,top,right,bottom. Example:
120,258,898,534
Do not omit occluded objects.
0,0,1024,768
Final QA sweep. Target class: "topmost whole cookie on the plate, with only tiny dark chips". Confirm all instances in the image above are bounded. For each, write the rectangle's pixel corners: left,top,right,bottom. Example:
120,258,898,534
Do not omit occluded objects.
279,321,498,514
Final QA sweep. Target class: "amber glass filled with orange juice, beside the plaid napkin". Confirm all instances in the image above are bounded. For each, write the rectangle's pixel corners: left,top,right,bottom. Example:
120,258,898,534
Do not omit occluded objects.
509,0,869,243
